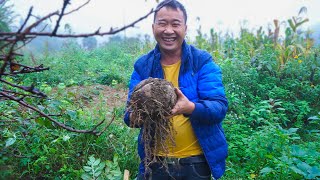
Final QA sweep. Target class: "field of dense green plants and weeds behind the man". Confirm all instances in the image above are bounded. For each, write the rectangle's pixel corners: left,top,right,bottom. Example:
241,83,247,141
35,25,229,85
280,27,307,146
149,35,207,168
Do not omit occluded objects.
0,10,320,180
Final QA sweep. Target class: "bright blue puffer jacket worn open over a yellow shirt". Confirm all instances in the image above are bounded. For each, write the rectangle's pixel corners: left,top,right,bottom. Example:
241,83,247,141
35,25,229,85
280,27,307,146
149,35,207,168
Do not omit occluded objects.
124,42,228,179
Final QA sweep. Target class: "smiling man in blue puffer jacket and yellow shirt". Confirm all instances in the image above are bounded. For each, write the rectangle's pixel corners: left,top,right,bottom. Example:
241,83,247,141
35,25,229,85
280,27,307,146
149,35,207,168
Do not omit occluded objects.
124,0,228,180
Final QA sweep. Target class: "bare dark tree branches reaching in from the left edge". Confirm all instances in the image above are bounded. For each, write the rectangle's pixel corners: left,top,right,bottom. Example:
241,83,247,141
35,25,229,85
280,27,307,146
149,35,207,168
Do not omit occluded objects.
0,0,165,136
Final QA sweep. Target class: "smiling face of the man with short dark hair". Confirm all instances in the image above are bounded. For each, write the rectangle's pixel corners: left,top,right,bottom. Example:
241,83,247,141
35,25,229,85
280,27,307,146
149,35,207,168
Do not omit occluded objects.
152,7,187,53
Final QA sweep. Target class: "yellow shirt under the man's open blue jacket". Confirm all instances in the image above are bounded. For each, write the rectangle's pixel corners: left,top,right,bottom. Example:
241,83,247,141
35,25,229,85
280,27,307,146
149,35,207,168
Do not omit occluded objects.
158,61,203,158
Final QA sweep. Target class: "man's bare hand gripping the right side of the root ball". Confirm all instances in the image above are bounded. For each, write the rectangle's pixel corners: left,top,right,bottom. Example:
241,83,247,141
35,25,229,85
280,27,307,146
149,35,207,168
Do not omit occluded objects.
171,88,195,116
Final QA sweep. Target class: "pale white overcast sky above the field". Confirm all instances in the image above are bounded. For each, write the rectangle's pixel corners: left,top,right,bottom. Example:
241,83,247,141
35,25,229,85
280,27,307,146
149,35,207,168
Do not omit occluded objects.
13,0,320,39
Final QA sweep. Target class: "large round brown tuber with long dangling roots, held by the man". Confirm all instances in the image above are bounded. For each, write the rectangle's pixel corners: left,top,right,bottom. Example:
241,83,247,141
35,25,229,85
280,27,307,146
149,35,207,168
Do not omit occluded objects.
128,78,177,172
